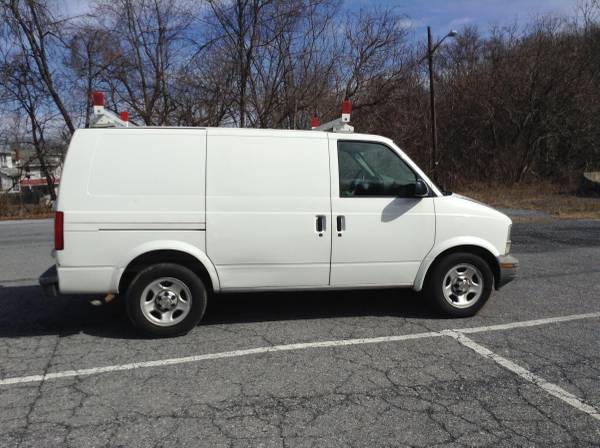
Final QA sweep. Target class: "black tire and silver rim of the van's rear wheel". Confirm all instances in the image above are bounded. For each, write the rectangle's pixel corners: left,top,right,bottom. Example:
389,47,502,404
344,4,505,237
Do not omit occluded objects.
127,263,207,337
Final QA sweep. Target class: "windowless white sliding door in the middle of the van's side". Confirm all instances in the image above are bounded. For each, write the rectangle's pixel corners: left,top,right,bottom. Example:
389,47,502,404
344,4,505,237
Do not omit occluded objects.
206,130,331,290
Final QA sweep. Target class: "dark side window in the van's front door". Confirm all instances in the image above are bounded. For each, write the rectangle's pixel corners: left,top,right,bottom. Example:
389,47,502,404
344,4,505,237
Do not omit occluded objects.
338,140,417,198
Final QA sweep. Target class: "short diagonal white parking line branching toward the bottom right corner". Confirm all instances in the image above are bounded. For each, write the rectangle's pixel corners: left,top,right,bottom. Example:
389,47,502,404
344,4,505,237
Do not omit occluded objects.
444,330,600,420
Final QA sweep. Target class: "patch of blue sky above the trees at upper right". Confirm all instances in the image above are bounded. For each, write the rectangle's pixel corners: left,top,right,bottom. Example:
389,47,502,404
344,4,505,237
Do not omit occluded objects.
344,0,577,36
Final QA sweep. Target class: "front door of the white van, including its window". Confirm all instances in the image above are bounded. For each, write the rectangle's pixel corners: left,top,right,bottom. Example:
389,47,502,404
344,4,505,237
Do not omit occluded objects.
330,136,435,287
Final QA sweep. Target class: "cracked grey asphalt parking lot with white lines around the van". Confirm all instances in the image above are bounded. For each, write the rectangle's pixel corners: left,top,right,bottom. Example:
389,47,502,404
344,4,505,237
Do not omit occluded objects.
0,220,600,447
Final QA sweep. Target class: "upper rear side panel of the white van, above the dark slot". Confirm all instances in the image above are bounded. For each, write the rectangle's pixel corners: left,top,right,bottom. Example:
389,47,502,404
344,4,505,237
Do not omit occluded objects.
59,129,206,217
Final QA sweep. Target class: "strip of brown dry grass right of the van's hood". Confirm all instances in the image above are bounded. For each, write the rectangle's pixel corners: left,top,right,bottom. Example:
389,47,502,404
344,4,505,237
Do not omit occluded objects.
458,183,600,219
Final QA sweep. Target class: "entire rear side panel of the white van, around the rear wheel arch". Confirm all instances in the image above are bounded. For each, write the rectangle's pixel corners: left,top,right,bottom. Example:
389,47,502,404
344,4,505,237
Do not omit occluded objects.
56,129,206,293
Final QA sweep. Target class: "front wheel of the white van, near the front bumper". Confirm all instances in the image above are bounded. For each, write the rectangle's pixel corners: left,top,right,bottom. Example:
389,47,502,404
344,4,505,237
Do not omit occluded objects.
425,252,494,317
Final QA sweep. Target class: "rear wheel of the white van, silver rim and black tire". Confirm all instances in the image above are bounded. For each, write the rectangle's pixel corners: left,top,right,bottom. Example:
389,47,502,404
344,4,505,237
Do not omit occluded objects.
127,263,207,337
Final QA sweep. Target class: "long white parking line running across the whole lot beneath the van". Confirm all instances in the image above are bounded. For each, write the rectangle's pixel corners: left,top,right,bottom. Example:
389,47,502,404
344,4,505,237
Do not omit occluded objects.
0,312,600,386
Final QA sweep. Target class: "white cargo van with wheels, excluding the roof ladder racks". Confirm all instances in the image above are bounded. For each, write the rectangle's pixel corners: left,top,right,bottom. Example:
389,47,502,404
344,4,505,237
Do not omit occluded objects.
40,128,518,336
